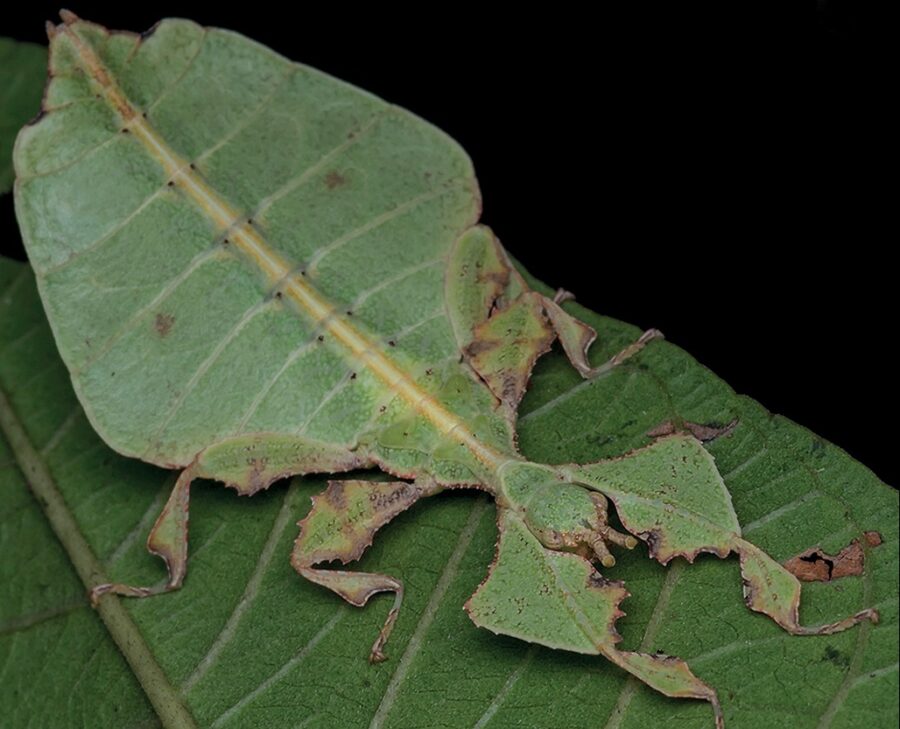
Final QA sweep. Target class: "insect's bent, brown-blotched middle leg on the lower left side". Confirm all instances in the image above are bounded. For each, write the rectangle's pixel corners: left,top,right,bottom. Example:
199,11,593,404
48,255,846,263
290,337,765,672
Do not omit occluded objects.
291,481,441,663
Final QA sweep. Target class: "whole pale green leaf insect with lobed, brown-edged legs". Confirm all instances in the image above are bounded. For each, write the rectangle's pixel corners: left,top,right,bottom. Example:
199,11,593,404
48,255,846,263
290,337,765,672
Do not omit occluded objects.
14,13,877,726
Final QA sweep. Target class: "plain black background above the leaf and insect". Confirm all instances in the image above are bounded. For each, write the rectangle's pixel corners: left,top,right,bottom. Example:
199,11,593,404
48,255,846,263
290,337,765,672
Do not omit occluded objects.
0,5,897,484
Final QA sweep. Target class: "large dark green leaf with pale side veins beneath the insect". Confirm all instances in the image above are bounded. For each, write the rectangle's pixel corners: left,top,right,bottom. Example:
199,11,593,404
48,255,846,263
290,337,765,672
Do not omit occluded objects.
0,262,898,729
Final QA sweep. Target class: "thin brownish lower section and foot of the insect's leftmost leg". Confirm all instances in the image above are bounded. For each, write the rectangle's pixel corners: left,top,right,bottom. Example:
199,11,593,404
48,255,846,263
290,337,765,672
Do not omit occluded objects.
90,466,194,606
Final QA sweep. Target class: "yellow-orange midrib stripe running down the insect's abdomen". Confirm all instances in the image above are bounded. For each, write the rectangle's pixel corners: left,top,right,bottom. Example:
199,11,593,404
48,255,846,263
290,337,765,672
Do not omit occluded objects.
63,25,509,468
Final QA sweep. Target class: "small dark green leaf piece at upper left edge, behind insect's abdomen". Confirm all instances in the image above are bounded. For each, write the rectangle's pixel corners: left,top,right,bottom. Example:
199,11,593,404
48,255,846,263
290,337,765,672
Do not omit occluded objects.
0,37,47,194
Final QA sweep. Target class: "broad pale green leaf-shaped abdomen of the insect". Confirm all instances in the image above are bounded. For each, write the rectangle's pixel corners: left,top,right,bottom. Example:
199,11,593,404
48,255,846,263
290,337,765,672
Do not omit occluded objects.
15,20,510,466
